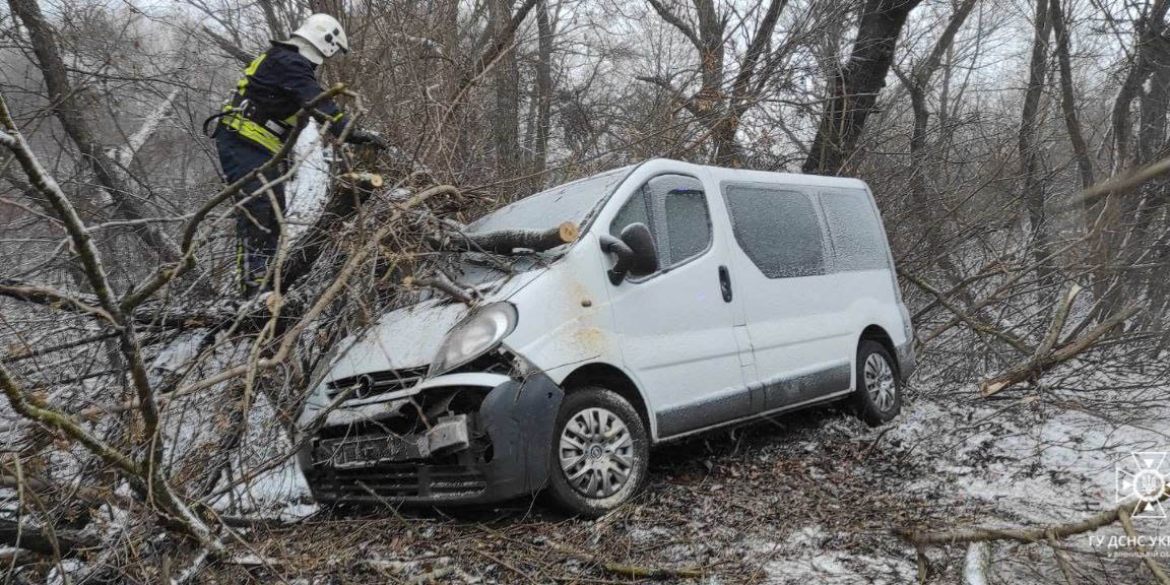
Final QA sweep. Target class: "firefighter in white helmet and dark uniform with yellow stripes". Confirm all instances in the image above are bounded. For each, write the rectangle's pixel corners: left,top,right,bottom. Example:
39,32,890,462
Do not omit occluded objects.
208,14,388,297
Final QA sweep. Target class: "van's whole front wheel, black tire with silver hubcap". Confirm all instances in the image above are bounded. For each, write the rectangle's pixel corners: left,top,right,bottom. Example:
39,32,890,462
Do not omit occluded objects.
549,386,649,518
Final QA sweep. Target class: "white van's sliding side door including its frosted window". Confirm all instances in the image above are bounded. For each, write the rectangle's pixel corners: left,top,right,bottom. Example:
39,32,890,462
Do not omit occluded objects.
722,183,855,412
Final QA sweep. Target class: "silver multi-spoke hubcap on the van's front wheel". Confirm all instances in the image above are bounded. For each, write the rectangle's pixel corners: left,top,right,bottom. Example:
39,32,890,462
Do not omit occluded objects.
559,408,634,497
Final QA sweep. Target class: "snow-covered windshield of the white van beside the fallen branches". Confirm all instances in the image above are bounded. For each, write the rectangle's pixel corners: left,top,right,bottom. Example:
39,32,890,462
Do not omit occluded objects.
467,165,633,233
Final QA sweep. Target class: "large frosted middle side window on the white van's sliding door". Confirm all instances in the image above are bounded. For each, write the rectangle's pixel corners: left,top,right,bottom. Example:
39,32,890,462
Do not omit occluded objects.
723,185,825,278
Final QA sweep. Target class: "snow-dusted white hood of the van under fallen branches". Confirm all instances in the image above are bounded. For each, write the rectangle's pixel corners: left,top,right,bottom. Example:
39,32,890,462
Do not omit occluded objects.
322,268,545,384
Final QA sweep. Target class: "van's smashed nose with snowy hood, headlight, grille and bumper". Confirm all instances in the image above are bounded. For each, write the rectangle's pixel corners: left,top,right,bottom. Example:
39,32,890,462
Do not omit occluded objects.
300,297,564,503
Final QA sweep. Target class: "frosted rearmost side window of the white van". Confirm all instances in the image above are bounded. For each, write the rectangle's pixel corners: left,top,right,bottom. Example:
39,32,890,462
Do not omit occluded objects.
820,188,889,271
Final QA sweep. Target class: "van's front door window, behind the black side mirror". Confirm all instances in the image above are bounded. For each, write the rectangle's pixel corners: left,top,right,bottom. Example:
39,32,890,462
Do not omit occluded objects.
610,174,711,269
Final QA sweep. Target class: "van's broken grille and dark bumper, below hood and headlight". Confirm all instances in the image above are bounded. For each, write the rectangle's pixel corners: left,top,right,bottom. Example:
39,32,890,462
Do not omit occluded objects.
302,373,564,503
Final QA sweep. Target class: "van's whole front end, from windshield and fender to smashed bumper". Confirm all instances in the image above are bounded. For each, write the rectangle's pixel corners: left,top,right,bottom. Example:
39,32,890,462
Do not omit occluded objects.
298,170,628,504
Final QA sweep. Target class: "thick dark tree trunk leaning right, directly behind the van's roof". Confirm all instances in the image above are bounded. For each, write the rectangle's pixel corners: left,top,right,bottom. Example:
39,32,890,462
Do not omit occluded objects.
804,0,921,174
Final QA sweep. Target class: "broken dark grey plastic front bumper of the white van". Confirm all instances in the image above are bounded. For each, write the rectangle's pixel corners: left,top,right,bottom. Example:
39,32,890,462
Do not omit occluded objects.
300,374,564,504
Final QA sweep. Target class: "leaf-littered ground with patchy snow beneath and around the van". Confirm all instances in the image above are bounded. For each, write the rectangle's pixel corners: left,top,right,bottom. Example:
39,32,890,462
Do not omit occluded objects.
212,388,1170,585
